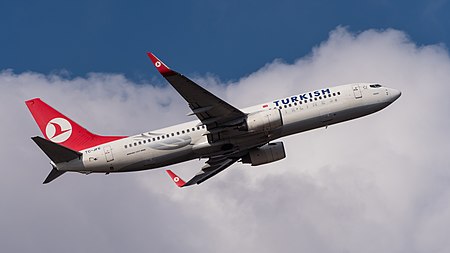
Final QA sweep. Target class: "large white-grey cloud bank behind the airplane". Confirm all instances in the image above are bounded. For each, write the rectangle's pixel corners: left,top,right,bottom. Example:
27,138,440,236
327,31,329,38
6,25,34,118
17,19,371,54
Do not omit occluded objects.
0,28,450,252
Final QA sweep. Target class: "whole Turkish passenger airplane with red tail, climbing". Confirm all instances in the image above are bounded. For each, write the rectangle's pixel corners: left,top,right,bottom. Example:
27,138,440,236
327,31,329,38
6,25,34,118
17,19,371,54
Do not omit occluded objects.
25,53,401,187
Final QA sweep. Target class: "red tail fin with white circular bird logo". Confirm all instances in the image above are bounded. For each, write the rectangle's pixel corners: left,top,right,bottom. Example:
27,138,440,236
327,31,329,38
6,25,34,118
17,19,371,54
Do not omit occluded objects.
25,98,125,151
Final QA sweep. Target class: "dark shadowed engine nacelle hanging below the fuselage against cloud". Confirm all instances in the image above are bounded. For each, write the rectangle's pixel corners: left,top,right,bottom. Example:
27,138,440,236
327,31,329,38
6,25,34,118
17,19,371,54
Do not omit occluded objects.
242,142,286,166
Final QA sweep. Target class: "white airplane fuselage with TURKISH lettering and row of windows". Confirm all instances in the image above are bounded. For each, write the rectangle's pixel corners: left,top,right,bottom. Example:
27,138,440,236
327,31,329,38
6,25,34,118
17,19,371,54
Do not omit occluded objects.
56,83,400,173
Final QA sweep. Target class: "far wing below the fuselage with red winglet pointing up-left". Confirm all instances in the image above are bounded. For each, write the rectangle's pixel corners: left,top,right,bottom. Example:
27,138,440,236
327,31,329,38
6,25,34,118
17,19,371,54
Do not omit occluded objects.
167,155,239,187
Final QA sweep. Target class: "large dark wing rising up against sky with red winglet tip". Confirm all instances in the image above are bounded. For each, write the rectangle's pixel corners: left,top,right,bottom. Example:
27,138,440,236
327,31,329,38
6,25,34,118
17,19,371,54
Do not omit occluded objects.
147,53,246,130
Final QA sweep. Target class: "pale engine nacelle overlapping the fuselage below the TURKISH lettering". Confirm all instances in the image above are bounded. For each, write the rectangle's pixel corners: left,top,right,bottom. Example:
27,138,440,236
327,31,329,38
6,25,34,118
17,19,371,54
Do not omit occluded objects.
244,110,283,132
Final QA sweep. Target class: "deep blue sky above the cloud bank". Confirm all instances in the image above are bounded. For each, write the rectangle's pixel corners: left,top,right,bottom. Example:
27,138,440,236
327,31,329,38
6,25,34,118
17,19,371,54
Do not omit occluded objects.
0,0,450,81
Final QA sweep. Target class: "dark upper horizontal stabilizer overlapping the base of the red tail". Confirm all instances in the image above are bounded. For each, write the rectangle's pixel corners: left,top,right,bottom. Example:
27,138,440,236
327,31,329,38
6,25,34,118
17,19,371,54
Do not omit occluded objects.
31,136,82,164
